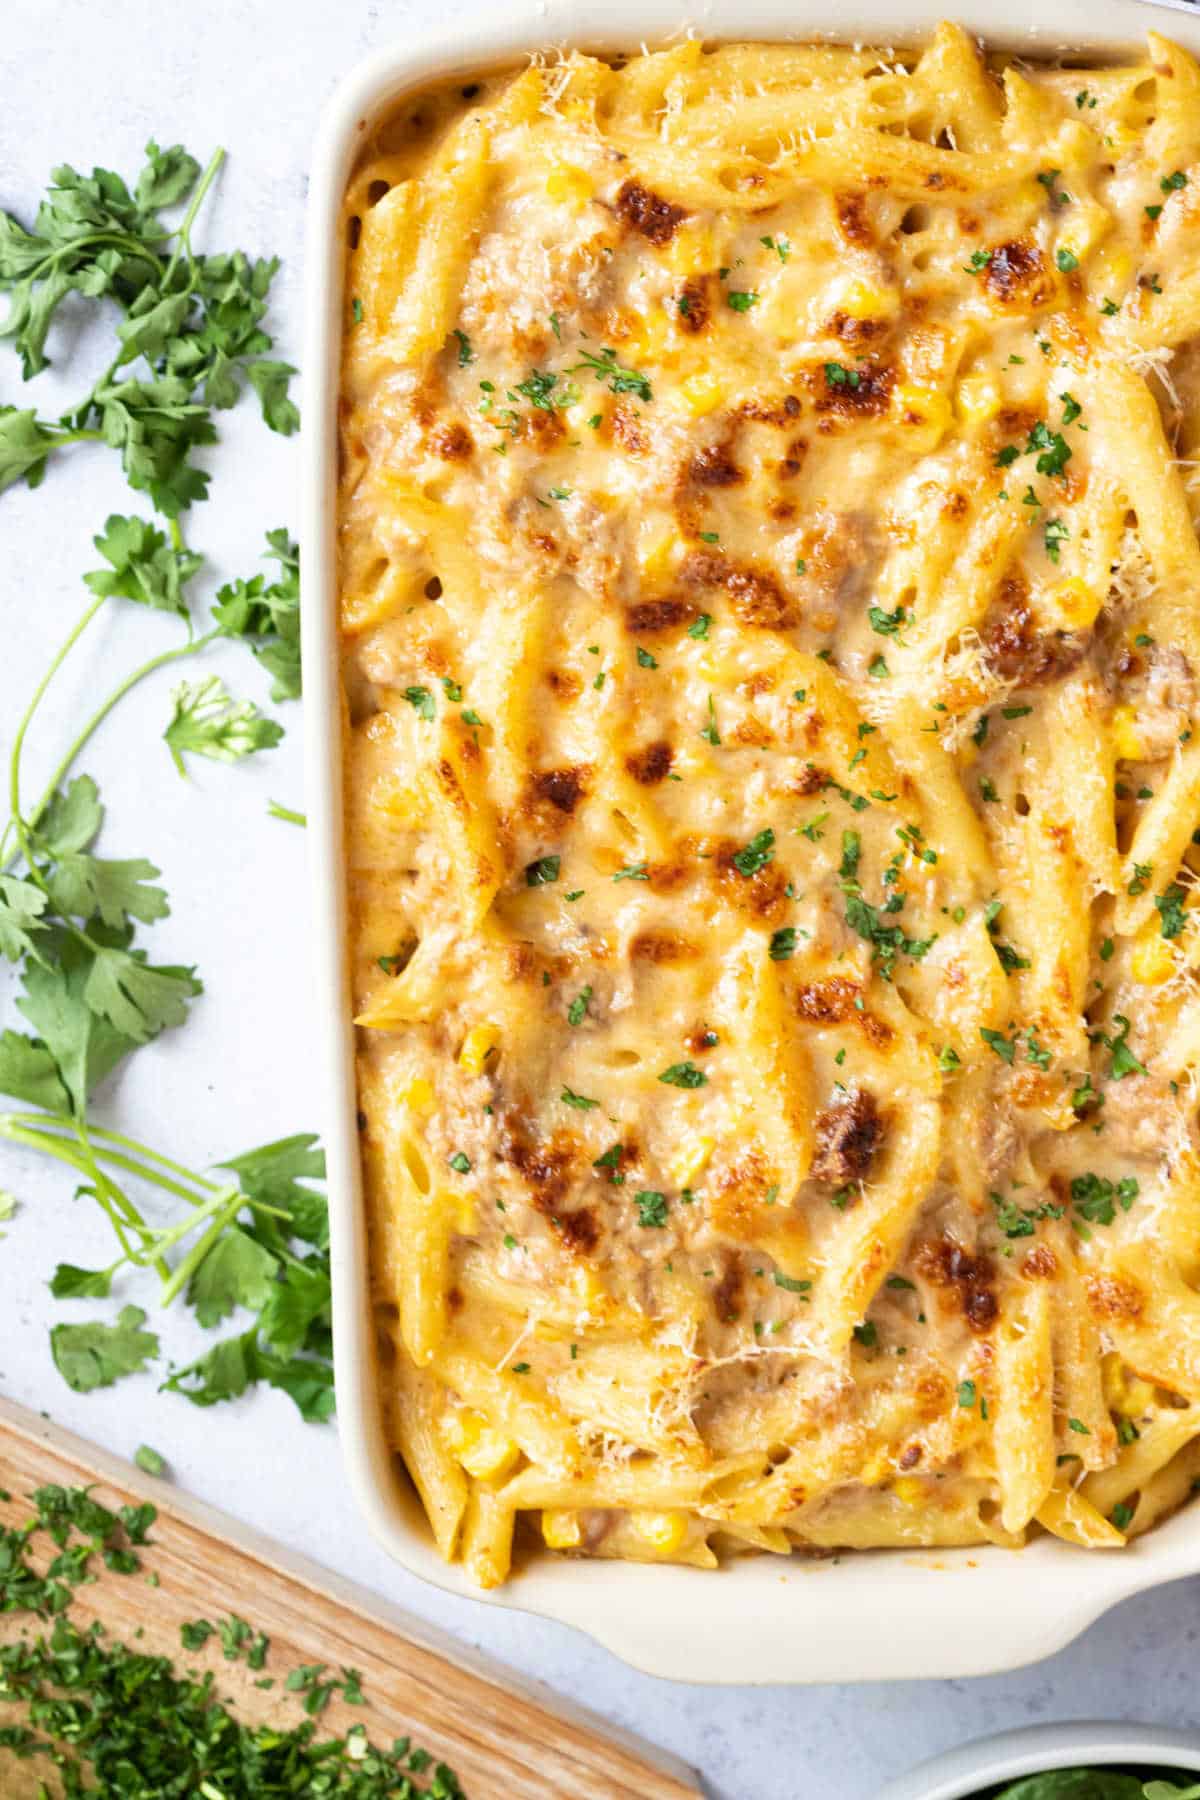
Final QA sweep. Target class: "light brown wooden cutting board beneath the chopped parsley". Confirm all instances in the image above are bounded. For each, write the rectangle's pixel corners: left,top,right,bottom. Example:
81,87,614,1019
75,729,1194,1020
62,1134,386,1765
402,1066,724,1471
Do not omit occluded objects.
0,1399,700,1800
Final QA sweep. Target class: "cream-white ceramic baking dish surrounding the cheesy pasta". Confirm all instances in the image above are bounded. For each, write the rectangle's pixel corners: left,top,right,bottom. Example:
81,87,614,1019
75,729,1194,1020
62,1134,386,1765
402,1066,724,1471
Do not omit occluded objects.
300,0,1200,1681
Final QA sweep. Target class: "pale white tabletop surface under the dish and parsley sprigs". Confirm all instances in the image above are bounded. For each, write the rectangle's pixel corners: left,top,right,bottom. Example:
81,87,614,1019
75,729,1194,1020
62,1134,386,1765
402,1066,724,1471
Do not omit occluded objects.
0,0,1200,1800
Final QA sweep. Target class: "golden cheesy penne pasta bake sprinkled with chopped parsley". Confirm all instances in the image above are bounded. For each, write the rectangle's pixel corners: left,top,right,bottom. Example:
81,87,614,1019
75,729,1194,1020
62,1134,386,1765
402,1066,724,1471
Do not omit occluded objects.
338,25,1200,1584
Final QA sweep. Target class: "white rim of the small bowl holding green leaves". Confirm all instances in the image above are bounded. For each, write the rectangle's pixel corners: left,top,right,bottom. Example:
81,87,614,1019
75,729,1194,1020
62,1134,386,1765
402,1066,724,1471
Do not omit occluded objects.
880,1721,1200,1800
